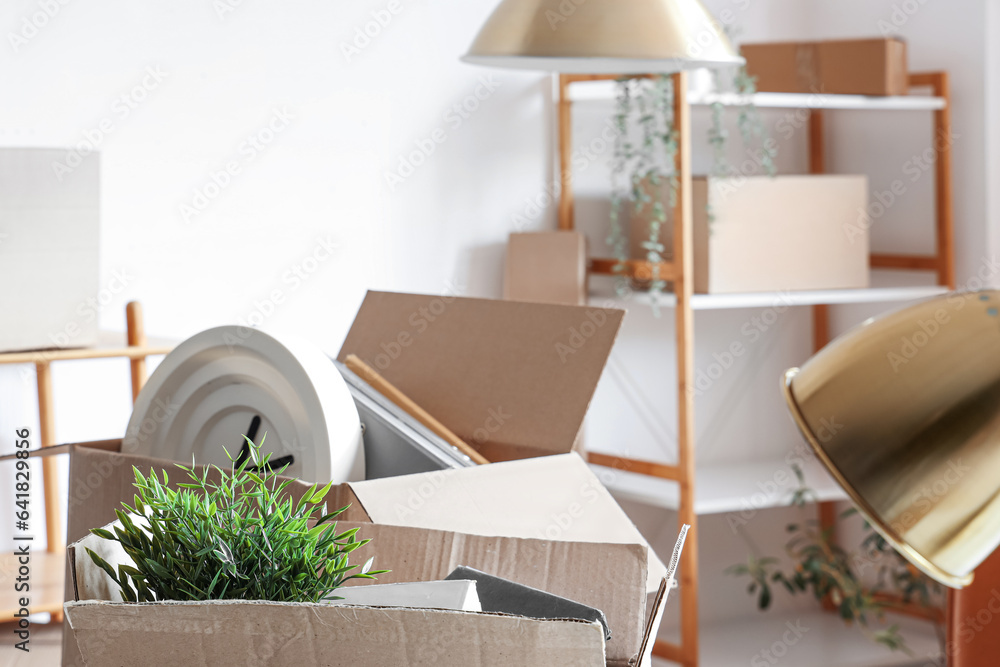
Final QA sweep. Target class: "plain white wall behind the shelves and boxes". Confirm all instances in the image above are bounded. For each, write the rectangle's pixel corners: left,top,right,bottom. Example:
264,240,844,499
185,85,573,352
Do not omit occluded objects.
0,0,1000,632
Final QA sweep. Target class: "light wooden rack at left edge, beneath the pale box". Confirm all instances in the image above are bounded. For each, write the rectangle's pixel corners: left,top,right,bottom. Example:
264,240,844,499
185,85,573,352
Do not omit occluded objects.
0,301,173,620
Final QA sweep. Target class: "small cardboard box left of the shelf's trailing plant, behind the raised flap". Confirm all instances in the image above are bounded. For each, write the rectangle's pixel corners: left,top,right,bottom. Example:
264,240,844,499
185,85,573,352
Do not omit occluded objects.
503,231,587,306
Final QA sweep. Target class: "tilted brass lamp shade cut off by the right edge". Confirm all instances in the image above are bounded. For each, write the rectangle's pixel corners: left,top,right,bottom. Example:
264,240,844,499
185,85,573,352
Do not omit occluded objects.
784,290,1000,588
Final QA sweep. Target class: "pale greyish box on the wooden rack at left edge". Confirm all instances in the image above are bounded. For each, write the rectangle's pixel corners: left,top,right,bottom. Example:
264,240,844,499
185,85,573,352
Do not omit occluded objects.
0,148,100,352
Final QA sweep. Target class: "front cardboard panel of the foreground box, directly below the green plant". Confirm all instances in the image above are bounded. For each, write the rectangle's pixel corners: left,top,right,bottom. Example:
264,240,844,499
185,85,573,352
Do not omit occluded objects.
66,601,605,667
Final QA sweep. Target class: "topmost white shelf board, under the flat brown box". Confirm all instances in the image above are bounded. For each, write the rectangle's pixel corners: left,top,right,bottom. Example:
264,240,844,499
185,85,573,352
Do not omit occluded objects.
569,81,947,111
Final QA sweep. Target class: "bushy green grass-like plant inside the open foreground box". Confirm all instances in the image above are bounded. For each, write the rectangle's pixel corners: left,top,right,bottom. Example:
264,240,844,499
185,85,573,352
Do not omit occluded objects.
87,439,388,602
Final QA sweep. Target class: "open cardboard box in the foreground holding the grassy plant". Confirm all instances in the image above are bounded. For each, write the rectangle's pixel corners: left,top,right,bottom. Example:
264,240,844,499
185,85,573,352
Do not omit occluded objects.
63,441,666,667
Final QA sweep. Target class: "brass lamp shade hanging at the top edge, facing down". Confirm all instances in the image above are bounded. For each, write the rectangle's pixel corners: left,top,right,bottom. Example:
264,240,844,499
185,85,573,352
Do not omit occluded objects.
462,0,743,74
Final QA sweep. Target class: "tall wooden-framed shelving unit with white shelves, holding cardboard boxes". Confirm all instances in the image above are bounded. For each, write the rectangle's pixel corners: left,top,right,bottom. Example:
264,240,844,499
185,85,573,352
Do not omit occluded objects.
557,72,955,667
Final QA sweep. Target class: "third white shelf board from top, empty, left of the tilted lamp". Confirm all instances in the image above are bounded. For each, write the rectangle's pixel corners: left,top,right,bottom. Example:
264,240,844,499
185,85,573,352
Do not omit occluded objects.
591,457,847,514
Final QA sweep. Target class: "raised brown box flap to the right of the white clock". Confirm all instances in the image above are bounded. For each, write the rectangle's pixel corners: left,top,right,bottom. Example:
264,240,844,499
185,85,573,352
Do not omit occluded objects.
337,292,624,461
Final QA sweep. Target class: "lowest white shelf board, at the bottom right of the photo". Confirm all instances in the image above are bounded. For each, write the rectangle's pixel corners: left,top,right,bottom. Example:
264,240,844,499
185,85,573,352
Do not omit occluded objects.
654,611,940,667
